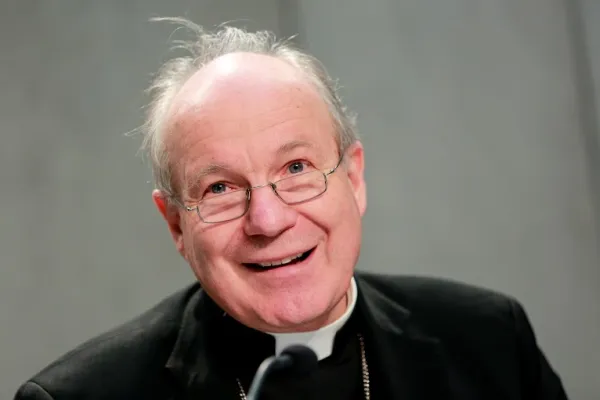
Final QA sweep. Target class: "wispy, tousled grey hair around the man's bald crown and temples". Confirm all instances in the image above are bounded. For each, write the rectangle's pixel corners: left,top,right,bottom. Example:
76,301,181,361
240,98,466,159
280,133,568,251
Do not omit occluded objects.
141,18,358,199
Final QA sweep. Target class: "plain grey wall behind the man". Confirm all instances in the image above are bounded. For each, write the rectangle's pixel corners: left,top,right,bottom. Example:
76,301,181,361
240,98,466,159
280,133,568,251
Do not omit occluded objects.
0,0,600,400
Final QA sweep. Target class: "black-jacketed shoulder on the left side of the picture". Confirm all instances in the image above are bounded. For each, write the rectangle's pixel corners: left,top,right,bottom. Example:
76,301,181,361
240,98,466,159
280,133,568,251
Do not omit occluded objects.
16,284,198,398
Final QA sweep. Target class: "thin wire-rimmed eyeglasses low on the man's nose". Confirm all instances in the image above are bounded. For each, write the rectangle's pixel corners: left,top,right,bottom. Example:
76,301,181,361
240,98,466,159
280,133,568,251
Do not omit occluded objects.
182,157,343,224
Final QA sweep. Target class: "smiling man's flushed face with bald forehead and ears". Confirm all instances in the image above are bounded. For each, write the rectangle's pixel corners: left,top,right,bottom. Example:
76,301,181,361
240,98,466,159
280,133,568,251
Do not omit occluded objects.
154,54,366,332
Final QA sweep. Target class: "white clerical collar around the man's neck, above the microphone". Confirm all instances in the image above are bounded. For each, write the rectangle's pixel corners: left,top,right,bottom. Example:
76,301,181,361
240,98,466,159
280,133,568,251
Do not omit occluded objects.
269,278,358,361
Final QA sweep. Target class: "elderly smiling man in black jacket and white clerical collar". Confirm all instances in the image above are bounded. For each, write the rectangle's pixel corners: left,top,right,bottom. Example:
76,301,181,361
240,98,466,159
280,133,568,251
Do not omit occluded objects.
16,20,566,400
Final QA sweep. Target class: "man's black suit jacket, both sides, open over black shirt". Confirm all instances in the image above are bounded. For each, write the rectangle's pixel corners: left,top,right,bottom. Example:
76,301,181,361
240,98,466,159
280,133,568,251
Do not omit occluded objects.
15,272,567,400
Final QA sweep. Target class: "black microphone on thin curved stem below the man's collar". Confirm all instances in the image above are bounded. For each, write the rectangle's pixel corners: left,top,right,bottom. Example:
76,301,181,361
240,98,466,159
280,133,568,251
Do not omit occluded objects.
246,345,318,400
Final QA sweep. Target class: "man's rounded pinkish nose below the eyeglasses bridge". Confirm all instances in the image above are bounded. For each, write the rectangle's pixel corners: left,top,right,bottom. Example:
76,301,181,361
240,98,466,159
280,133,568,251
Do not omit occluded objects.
244,185,298,237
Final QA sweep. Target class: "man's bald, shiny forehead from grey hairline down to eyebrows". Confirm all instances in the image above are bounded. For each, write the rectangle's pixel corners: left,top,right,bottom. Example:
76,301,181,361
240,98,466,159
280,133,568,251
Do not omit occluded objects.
167,54,335,167
